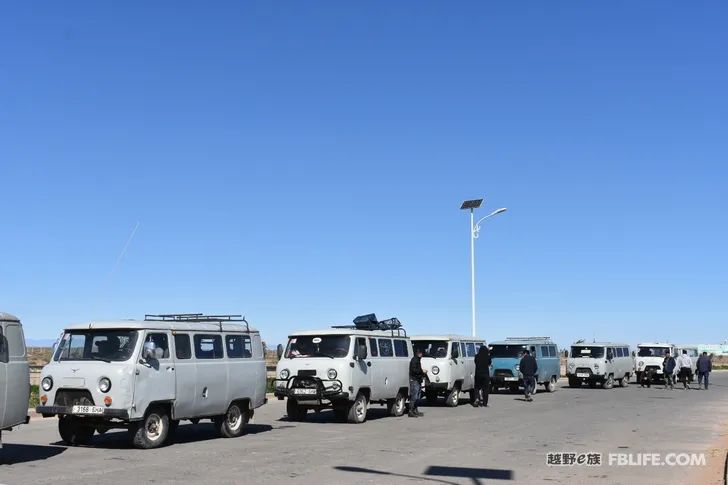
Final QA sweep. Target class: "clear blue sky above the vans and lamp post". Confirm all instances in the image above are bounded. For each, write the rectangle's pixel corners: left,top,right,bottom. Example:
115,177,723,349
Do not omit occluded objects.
0,1,728,346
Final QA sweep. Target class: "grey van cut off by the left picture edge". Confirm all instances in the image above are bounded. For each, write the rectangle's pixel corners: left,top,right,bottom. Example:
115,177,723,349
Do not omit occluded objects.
0,312,30,448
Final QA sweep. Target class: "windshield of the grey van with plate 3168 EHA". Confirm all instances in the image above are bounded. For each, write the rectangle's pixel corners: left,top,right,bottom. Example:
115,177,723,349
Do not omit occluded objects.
53,330,138,362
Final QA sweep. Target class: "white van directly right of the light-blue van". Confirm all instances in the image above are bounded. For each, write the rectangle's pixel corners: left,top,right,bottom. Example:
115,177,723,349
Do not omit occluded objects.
566,340,634,389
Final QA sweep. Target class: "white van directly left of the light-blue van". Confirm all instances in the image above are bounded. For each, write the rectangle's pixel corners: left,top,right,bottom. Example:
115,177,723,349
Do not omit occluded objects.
412,335,485,407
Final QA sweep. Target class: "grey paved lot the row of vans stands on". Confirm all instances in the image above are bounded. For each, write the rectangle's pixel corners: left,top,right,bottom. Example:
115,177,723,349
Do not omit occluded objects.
0,372,728,485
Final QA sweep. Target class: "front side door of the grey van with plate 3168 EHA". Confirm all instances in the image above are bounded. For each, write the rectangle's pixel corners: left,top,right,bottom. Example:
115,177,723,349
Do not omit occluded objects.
132,330,175,417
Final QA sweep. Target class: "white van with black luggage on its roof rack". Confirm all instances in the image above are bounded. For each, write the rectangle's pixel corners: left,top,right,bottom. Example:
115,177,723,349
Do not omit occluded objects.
274,314,413,423
